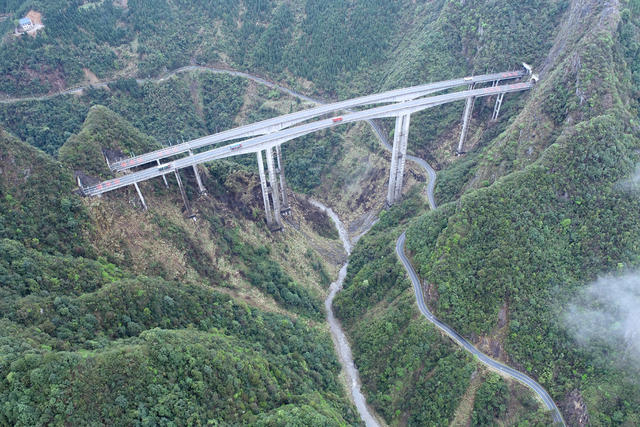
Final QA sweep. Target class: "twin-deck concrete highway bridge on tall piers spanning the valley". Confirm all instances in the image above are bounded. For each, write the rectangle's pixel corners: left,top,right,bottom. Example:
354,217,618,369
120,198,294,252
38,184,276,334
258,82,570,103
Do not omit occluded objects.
78,66,535,229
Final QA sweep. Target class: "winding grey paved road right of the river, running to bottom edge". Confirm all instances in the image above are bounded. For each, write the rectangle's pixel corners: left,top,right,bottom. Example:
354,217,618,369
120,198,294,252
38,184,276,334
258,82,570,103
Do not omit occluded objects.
396,231,566,425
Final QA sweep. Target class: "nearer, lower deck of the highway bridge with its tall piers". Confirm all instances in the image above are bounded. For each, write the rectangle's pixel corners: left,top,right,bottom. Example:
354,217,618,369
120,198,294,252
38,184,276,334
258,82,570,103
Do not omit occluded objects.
81,69,533,228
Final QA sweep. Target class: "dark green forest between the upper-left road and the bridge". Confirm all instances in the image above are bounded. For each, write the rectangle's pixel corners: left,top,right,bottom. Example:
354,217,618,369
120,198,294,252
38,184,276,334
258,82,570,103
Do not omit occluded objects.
0,73,246,155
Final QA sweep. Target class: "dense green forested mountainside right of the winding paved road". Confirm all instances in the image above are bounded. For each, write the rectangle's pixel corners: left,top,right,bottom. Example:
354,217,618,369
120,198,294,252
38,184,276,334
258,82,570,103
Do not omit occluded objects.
408,4,640,425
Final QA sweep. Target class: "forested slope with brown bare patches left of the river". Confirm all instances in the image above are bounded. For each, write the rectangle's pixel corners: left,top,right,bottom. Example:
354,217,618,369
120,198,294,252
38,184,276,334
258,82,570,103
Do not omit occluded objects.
0,112,356,425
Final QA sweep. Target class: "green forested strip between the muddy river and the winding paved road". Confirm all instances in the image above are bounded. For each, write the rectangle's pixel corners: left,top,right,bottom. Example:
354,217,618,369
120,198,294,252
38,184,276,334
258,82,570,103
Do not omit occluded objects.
335,196,550,425
